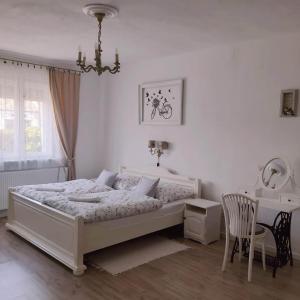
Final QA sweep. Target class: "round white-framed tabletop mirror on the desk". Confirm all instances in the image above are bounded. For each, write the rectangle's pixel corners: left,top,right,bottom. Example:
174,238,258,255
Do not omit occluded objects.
261,158,290,190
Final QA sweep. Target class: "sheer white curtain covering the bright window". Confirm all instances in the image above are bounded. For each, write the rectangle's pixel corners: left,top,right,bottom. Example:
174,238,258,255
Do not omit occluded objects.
0,63,65,171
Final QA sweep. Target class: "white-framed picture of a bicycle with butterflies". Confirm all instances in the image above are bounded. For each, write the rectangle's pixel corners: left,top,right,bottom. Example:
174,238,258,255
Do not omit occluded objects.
139,79,183,125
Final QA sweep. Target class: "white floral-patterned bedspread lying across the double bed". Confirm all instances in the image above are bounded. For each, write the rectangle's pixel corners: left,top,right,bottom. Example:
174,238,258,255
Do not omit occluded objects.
14,179,163,222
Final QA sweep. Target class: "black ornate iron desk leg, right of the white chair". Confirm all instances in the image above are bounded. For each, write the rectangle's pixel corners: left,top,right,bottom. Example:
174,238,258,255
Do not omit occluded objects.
259,211,293,277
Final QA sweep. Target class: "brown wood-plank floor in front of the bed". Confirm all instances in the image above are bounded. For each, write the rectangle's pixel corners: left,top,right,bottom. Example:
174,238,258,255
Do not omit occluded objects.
0,219,300,300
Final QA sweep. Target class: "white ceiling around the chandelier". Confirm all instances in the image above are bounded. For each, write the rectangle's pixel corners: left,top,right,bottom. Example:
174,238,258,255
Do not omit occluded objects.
0,0,300,62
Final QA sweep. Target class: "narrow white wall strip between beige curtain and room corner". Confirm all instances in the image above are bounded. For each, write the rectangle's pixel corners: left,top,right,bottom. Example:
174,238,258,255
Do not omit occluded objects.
76,73,103,178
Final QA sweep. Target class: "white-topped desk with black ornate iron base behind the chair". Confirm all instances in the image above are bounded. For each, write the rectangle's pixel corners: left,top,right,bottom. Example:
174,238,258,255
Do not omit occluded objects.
256,197,300,277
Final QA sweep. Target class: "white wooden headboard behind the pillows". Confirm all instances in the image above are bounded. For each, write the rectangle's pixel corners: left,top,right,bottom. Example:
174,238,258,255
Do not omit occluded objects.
120,166,201,198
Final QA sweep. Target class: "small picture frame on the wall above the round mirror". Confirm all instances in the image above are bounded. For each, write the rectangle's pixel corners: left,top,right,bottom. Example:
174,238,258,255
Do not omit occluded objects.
280,89,298,117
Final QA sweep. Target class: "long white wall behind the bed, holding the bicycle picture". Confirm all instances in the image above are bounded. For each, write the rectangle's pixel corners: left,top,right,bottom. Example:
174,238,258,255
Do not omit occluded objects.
102,36,300,253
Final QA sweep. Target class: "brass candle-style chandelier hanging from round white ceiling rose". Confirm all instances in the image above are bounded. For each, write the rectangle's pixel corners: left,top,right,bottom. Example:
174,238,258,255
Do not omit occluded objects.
76,4,121,76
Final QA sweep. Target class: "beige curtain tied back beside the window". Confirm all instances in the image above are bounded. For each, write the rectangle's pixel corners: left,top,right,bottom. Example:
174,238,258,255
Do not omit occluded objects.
49,69,80,180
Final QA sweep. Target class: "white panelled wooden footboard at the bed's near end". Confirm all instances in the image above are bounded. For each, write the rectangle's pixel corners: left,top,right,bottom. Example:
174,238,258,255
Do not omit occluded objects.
6,192,86,275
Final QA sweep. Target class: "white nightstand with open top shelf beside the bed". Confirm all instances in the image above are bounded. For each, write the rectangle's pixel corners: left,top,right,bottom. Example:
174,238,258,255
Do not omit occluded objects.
184,199,222,245
